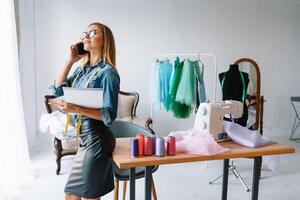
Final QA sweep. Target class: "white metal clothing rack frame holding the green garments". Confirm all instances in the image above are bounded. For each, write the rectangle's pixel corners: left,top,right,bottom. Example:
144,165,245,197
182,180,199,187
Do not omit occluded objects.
151,53,217,119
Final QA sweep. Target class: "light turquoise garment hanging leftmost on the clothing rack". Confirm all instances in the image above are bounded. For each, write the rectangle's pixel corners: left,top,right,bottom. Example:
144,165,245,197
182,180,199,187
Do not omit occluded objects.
157,60,172,111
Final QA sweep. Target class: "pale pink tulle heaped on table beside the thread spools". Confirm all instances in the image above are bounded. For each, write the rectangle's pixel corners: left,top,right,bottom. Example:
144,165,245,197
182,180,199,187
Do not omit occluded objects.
169,129,229,155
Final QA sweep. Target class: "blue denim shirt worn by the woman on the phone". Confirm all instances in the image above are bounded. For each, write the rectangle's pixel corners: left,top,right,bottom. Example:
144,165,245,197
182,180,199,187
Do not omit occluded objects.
51,60,120,125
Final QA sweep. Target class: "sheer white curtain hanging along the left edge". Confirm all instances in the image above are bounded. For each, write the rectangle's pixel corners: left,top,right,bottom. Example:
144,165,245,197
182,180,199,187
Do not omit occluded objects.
0,0,33,200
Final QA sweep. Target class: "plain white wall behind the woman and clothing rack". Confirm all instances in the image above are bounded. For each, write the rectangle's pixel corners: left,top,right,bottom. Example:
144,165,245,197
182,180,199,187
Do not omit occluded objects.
19,0,300,141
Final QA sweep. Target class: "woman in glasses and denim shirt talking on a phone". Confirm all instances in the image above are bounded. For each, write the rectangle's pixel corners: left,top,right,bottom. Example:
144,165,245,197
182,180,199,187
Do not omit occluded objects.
53,23,120,200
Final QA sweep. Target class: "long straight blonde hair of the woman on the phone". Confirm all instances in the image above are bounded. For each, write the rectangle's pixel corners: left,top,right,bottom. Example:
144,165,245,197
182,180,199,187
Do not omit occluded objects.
81,22,116,68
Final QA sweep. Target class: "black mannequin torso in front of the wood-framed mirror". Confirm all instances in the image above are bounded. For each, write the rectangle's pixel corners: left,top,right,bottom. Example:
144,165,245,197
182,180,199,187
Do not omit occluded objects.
219,64,249,126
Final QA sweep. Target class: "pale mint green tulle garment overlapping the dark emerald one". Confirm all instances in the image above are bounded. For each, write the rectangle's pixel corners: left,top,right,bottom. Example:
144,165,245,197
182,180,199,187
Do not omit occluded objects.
175,59,199,107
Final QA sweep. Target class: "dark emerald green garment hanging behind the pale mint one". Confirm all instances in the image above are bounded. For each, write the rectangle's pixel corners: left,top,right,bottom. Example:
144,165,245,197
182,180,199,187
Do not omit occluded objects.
170,59,191,118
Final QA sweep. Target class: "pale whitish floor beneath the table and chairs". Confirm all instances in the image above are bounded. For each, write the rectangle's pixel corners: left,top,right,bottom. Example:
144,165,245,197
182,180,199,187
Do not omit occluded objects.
22,130,300,200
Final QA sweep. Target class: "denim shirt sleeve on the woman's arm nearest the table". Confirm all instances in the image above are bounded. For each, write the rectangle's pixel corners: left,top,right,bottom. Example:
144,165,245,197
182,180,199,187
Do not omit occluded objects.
100,69,120,125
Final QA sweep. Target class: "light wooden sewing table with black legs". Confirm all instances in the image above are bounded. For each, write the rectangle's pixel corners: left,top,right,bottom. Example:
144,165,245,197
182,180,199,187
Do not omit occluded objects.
113,138,295,200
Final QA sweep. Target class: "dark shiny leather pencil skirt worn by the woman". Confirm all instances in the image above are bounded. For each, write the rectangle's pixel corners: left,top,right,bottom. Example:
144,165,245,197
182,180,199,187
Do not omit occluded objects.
65,117,116,198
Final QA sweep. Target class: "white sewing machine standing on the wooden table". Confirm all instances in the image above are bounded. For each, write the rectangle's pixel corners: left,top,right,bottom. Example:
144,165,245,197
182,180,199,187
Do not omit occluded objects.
194,100,243,141
